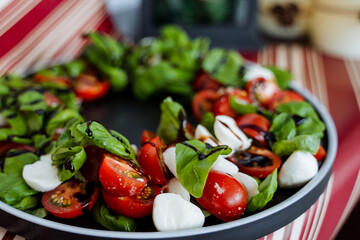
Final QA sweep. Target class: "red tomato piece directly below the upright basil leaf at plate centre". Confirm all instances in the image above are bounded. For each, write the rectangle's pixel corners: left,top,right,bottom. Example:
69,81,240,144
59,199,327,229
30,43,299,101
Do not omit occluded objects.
138,134,168,185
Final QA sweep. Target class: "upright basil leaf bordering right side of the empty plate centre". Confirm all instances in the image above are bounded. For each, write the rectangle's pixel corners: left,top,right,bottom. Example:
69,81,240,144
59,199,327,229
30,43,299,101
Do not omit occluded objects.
157,97,186,144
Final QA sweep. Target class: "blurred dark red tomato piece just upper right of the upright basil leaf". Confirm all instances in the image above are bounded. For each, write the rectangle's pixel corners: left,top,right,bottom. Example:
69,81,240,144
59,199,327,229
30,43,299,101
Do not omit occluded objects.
192,89,219,121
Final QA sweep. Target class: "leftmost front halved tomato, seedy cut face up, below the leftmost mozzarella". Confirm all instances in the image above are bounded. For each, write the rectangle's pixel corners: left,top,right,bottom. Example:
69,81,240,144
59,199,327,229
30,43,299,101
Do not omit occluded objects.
41,180,100,219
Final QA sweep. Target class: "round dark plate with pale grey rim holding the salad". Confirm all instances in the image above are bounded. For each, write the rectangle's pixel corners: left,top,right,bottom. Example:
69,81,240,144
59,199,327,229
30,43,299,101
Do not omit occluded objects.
0,83,337,240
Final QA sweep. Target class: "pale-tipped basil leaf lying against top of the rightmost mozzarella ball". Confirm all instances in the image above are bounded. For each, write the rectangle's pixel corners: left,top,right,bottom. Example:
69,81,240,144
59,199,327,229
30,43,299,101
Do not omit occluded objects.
272,135,320,156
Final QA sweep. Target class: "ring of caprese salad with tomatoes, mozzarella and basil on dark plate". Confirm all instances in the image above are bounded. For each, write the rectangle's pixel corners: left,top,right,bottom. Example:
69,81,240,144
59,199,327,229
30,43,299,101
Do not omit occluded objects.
0,26,326,231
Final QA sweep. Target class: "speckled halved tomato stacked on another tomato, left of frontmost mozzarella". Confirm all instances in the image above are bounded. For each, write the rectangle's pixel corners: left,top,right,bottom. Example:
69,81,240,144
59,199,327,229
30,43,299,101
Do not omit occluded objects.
99,153,149,196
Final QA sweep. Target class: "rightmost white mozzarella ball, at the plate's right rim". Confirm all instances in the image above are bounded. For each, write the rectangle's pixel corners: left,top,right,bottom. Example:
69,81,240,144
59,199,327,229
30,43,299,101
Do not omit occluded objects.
279,151,319,188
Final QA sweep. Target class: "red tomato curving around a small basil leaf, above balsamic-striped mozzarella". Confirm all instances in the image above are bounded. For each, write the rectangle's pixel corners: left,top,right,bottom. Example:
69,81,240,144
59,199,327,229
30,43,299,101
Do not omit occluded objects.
213,89,250,118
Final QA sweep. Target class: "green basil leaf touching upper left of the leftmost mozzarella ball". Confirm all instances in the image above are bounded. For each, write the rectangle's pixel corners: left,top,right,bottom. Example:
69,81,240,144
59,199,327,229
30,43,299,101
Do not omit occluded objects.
4,152,39,177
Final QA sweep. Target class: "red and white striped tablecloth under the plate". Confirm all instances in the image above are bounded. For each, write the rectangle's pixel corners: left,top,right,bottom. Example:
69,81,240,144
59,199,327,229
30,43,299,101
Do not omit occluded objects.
0,0,360,240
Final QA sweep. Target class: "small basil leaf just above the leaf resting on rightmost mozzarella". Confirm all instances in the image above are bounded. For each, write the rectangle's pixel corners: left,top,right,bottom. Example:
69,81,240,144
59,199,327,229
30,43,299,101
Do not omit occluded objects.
269,113,296,141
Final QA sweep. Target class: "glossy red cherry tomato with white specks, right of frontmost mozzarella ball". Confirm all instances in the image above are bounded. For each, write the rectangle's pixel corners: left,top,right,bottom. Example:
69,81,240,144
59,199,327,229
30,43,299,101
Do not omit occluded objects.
196,171,247,222
